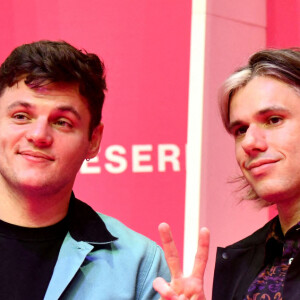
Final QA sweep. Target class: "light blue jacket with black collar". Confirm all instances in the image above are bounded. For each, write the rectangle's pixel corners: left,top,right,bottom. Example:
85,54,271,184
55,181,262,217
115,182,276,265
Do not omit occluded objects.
44,195,170,300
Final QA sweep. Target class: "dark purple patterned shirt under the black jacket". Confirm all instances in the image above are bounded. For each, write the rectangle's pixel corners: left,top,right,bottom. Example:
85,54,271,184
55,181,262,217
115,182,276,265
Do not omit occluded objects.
244,219,300,300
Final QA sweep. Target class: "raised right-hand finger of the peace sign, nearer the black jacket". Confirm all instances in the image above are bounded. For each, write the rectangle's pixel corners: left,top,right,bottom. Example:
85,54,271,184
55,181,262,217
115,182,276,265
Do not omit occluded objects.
192,227,209,280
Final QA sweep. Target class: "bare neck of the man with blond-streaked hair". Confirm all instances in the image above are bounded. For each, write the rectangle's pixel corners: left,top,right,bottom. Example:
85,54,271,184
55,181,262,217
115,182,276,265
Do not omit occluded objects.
277,200,300,235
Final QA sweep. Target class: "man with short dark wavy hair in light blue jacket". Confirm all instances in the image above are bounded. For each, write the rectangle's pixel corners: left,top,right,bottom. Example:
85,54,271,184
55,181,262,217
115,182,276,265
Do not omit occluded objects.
0,41,169,300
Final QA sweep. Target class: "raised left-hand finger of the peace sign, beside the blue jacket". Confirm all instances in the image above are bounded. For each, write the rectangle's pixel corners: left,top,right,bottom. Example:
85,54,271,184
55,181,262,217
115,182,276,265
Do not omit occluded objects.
158,223,182,279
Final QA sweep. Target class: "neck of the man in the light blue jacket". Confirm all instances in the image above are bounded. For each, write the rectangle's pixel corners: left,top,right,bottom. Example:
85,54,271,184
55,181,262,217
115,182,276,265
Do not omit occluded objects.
0,180,72,227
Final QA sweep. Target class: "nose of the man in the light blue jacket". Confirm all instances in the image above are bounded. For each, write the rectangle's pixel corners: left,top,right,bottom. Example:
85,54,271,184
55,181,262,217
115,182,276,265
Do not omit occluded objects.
26,119,53,148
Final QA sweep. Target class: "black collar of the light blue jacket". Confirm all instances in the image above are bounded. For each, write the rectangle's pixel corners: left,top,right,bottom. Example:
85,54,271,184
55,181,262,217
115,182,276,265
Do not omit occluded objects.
68,193,117,244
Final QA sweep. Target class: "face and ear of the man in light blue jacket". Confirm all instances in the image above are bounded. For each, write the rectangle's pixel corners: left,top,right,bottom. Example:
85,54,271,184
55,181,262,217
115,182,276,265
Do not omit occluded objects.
0,80,102,193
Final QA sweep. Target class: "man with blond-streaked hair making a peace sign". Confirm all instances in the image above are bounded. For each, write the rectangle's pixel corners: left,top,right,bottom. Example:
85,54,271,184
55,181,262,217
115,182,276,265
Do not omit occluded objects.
154,49,300,300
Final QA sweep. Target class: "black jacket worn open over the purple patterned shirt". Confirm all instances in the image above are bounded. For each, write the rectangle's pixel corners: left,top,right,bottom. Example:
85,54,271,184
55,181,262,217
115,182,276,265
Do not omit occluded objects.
212,217,300,300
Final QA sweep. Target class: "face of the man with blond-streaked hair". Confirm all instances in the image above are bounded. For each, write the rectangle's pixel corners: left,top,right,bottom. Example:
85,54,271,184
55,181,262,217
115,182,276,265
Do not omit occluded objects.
230,76,300,203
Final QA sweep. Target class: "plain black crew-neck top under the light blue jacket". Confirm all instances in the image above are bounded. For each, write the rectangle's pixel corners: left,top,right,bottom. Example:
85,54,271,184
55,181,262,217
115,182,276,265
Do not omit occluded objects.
0,217,68,300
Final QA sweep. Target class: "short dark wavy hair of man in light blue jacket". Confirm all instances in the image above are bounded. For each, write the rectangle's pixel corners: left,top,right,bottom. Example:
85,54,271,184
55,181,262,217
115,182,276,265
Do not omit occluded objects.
0,40,106,137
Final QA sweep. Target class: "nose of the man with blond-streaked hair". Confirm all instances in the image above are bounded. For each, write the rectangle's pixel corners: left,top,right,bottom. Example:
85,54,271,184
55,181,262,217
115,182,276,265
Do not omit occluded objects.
241,124,268,156
